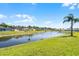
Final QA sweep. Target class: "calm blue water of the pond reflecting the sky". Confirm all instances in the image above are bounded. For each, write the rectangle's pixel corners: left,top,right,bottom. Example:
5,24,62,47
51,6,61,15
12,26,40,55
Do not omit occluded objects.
0,32,62,48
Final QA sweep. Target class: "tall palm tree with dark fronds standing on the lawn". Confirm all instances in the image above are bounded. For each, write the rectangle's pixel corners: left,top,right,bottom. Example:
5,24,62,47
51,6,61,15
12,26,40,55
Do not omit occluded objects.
63,14,79,36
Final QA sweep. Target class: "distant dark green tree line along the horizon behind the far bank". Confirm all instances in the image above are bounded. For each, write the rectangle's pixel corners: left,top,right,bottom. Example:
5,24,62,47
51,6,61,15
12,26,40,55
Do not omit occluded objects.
0,23,57,31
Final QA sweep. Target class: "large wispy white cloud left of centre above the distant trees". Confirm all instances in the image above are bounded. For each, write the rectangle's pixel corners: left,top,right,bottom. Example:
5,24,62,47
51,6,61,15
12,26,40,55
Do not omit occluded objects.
10,14,37,26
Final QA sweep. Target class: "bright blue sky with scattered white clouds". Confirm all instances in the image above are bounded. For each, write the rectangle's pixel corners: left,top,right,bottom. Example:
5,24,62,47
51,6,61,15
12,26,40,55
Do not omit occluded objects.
0,3,79,28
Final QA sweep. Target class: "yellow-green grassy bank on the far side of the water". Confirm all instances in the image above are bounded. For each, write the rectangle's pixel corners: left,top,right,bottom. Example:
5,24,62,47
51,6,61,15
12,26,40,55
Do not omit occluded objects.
0,31,44,38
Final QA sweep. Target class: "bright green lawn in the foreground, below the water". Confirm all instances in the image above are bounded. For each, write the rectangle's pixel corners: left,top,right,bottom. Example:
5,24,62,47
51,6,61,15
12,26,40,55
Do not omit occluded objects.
0,33,79,56
